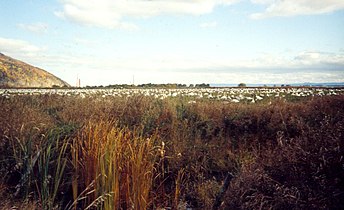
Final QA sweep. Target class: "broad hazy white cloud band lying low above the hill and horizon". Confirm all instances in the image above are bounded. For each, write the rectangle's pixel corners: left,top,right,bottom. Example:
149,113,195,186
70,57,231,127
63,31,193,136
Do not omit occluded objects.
0,37,344,85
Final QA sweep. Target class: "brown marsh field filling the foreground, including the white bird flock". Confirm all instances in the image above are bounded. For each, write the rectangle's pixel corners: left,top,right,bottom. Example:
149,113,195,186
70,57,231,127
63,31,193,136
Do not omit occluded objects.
0,88,344,209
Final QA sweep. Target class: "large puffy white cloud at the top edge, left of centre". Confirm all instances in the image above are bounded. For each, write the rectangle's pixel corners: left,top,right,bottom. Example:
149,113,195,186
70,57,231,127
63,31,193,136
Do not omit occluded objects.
55,0,238,29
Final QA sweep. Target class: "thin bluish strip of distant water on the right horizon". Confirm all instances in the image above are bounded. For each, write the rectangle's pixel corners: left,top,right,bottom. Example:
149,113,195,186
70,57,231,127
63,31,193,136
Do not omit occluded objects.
210,82,344,87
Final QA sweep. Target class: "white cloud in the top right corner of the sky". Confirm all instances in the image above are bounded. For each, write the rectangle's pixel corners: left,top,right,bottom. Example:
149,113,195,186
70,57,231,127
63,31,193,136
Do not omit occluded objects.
250,0,344,19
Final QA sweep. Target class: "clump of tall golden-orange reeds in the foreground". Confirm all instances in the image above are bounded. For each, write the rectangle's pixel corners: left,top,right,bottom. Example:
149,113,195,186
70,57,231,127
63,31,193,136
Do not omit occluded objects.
72,121,157,209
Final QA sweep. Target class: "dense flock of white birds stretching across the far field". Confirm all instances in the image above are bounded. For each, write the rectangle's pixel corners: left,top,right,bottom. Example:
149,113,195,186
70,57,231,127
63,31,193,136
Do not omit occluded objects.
0,87,344,103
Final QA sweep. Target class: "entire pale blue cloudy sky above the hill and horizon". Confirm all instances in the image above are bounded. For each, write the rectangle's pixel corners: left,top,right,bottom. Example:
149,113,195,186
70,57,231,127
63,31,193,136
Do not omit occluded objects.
0,0,344,86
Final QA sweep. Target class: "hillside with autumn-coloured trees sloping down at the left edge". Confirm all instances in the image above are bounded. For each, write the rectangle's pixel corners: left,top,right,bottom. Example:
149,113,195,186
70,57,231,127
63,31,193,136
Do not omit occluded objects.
0,53,70,87
